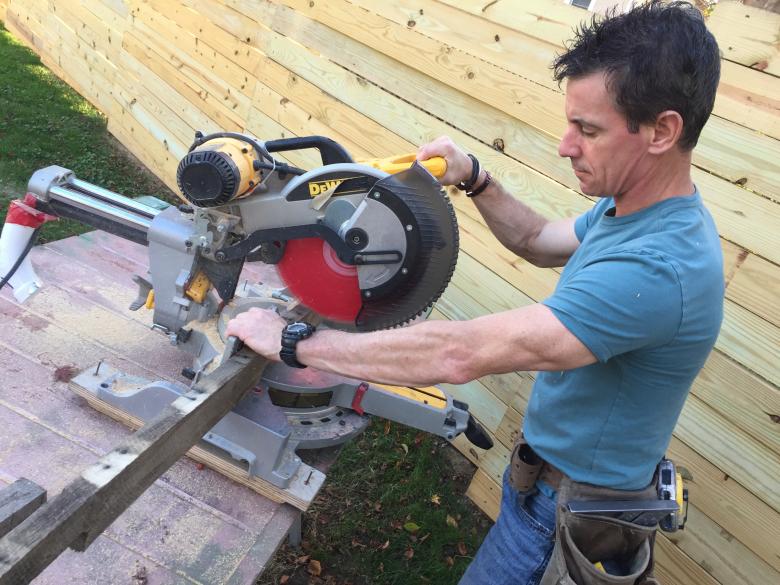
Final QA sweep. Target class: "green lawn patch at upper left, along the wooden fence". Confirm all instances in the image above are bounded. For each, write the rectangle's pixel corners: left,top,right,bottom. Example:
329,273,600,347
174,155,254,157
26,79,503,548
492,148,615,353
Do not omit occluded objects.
0,23,175,242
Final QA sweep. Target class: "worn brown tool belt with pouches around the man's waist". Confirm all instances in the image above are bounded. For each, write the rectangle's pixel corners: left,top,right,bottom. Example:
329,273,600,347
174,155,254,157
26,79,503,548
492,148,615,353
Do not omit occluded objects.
509,435,659,585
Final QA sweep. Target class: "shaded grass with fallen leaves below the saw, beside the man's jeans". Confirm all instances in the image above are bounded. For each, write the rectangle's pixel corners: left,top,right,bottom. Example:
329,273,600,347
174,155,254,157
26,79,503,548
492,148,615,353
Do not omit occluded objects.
259,419,489,585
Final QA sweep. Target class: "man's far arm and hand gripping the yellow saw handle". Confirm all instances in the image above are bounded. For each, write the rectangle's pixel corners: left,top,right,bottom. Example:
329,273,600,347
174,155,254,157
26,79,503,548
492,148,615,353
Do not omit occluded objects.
417,136,579,266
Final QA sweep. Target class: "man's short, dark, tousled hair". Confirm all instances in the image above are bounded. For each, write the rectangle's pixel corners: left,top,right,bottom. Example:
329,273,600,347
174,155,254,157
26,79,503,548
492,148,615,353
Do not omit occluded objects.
553,1,720,150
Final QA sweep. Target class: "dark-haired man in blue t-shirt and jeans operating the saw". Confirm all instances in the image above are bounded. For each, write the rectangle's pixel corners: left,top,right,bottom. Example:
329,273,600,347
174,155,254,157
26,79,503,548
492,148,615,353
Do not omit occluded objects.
227,2,723,584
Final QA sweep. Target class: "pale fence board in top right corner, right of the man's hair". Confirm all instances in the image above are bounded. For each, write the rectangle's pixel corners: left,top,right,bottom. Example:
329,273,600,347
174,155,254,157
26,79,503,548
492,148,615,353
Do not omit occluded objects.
707,0,780,75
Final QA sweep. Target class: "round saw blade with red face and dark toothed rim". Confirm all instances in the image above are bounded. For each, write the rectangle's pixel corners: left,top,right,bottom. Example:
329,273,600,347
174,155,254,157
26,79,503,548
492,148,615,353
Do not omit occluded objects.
277,164,459,331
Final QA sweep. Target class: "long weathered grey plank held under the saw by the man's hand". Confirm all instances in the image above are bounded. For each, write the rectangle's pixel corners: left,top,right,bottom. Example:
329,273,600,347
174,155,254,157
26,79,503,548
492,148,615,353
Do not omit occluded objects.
0,350,266,585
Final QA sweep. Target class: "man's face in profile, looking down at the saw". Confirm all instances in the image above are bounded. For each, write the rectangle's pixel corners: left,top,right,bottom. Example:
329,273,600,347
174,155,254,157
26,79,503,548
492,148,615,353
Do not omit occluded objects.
558,73,652,197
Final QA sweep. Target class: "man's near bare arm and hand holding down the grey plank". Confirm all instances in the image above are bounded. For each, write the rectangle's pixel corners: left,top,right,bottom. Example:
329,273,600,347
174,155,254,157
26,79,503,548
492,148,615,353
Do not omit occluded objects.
226,304,596,386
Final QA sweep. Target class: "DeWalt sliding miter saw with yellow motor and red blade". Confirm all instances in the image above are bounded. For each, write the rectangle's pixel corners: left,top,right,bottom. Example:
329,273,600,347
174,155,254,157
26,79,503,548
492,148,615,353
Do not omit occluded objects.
0,132,492,488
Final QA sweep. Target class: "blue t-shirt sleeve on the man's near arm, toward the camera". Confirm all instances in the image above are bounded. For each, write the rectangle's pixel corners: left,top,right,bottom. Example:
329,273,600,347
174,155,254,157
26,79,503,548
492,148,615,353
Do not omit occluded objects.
542,252,683,362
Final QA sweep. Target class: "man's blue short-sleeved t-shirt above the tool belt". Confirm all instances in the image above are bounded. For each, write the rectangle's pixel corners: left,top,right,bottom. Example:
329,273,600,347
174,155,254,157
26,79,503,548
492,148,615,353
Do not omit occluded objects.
523,191,724,490
